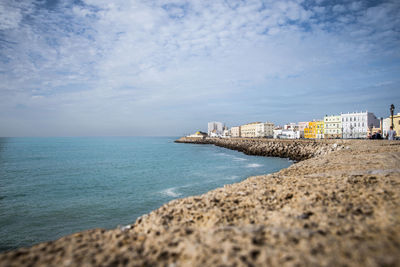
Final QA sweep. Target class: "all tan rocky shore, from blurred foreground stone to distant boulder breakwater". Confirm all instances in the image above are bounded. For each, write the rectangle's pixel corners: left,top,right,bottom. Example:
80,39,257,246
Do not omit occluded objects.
0,139,400,266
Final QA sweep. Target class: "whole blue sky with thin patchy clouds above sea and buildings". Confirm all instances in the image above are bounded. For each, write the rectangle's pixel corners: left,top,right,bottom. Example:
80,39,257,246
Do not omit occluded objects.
0,0,400,136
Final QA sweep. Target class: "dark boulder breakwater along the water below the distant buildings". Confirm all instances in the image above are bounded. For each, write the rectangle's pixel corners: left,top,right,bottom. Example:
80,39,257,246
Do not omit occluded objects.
175,137,346,161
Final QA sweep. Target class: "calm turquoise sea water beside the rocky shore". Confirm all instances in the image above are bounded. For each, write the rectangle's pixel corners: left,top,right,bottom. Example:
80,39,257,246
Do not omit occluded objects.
0,137,291,251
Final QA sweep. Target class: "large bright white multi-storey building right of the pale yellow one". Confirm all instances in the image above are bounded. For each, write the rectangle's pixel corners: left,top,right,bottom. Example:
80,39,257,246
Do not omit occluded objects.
341,111,380,138
